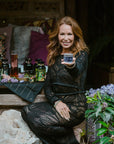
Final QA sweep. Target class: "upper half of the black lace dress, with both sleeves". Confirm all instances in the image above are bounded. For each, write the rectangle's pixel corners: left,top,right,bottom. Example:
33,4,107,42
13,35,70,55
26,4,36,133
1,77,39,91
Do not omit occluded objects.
44,51,88,104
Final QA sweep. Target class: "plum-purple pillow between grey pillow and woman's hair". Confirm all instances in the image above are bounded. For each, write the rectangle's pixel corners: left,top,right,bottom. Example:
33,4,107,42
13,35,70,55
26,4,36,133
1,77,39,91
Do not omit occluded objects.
28,31,49,65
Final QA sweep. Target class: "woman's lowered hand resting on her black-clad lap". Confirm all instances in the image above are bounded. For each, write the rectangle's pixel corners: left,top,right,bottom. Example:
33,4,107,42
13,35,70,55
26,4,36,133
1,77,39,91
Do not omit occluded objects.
55,101,70,120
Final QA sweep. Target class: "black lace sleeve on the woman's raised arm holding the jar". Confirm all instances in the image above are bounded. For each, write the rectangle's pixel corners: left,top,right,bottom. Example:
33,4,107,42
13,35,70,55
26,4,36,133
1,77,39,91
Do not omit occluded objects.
66,51,88,76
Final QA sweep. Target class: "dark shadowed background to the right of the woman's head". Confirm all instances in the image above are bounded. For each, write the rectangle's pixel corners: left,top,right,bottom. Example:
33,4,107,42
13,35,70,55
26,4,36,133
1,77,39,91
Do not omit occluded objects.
65,0,114,88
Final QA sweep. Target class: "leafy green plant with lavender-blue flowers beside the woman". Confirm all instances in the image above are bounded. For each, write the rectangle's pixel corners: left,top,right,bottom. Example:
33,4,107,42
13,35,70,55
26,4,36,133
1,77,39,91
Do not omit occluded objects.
85,84,114,144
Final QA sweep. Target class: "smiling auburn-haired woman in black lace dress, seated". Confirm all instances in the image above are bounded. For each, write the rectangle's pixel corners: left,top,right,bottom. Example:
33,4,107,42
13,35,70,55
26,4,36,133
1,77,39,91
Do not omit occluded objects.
22,16,88,144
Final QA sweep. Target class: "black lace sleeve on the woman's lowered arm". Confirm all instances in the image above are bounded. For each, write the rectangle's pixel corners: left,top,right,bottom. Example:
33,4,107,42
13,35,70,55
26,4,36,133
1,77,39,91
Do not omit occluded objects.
44,68,59,105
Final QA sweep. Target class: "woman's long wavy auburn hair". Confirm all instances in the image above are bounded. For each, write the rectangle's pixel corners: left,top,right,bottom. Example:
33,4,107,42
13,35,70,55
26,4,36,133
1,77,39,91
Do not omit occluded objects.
47,16,88,66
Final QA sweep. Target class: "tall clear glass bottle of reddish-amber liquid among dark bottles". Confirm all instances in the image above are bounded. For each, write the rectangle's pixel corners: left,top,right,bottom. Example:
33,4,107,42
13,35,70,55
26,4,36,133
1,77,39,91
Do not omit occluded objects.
10,54,18,77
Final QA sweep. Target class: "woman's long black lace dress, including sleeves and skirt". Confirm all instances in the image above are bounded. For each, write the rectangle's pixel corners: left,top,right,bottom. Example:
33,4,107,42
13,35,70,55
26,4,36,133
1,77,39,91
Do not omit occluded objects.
22,51,88,144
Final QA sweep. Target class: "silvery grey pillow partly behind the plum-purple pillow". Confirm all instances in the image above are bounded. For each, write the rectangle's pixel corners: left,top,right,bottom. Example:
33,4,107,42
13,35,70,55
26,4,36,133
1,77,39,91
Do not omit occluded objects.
12,26,44,64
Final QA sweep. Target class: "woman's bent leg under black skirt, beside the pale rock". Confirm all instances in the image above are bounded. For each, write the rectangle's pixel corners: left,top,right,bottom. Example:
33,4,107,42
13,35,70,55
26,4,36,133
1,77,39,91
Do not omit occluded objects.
22,103,79,144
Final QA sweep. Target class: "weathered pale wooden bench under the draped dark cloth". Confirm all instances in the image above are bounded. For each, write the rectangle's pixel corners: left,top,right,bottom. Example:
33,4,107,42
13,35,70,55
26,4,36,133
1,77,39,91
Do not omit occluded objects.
0,86,86,142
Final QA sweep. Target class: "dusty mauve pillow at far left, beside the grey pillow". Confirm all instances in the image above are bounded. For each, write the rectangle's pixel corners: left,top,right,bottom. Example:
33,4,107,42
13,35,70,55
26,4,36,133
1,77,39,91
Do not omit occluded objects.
0,26,12,63
